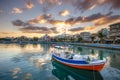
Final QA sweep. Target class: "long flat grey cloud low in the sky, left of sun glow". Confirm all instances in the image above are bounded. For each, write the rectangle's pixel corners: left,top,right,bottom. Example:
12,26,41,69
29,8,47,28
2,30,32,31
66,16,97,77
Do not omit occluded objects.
20,26,58,34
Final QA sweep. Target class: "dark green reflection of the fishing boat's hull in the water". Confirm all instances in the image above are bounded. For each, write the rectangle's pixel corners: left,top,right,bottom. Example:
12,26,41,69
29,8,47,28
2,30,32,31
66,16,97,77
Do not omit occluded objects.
52,61,103,80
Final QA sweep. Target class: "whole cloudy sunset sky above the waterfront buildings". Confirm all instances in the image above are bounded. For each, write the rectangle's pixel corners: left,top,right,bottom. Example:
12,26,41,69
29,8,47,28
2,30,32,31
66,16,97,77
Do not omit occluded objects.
0,0,120,37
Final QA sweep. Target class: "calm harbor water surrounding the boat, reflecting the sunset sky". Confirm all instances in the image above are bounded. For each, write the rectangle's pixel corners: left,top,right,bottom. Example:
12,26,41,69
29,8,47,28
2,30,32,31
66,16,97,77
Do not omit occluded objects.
0,44,120,80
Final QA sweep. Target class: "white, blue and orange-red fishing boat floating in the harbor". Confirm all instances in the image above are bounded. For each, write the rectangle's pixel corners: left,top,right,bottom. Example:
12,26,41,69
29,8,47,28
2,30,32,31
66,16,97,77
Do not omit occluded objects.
52,51,106,71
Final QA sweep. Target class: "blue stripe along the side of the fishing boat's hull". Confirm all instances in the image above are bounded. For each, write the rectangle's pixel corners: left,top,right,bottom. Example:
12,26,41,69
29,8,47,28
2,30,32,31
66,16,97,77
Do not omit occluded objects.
52,55,88,64
